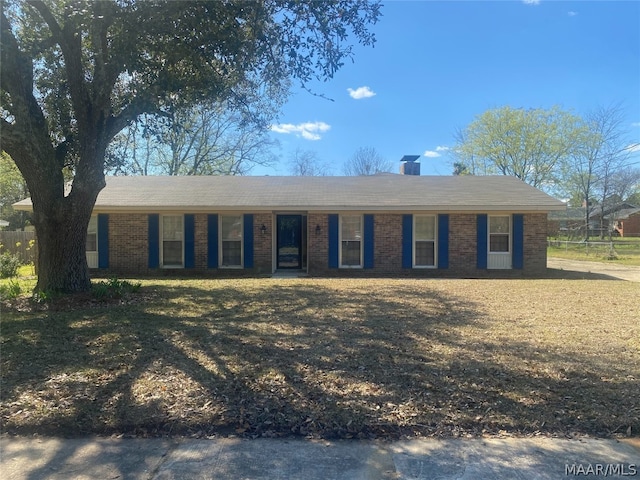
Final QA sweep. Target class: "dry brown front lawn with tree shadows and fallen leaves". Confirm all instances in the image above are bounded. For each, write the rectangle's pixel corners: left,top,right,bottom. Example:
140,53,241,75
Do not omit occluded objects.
0,279,640,438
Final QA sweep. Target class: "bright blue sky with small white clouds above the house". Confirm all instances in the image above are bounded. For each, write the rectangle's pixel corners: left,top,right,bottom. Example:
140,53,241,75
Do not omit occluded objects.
262,0,640,175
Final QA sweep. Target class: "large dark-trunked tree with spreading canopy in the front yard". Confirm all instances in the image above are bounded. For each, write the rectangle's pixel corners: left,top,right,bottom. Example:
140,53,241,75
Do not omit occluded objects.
0,0,381,292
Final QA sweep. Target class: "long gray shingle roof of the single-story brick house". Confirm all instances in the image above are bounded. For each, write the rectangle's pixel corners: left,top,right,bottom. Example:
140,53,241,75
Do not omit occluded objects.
19,174,565,212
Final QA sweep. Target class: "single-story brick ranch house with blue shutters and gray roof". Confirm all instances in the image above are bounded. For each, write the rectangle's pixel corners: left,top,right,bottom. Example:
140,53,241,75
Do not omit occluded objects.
16,160,565,277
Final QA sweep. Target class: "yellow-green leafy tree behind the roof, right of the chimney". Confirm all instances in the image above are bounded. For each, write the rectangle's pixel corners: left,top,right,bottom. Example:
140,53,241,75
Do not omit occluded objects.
453,106,582,189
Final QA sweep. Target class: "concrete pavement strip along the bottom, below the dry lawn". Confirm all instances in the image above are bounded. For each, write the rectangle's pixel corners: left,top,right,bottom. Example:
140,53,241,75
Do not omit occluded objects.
0,436,640,480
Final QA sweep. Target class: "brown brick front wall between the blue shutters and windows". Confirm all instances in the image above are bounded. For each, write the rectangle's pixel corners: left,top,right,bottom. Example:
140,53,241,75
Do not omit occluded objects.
100,213,547,277
